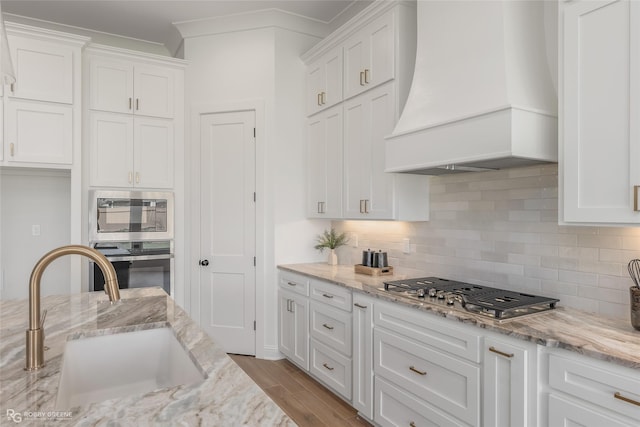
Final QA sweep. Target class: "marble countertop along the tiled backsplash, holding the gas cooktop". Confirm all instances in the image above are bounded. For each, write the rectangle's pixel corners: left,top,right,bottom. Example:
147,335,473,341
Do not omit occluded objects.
278,263,640,369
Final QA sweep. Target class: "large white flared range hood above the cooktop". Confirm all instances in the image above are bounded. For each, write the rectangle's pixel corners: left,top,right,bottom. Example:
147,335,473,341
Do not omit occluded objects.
386,0,558,175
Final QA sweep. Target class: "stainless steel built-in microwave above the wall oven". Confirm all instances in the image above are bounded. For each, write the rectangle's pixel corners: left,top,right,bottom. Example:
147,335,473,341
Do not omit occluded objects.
89,190,173,242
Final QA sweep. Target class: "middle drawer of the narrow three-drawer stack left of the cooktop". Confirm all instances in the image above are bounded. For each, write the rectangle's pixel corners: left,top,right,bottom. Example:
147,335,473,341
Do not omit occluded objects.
309,301,351,357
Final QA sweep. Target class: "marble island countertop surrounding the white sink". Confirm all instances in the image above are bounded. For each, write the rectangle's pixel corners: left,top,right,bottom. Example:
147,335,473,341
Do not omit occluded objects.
0,288,295,426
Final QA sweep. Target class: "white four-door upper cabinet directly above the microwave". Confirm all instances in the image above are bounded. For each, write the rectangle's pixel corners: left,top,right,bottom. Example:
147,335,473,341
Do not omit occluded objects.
85,46,184,189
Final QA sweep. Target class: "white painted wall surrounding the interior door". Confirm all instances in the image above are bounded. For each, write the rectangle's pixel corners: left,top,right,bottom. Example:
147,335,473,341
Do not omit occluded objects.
184,27,319,357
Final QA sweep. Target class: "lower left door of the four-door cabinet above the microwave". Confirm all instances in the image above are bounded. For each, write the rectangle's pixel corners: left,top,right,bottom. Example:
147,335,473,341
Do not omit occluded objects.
89,111,133,187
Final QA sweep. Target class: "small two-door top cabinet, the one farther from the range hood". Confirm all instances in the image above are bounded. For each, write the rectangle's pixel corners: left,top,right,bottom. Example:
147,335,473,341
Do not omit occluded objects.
307,46,342,115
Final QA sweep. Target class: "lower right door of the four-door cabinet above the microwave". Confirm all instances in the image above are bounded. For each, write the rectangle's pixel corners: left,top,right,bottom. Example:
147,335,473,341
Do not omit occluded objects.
133,117,175,188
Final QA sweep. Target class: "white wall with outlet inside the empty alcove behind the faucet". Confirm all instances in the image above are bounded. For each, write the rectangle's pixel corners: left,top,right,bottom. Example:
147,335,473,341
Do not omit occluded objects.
0,168,71,299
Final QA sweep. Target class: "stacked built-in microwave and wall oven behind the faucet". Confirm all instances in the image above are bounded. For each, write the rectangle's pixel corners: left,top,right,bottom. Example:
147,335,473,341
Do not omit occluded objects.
89,190,174,295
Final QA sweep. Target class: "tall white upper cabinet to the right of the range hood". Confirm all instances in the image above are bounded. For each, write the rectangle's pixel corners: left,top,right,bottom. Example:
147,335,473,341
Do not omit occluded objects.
559,0,640,224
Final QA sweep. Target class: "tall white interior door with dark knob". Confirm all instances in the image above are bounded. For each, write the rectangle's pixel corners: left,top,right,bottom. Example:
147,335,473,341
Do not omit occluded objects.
199,111,256,355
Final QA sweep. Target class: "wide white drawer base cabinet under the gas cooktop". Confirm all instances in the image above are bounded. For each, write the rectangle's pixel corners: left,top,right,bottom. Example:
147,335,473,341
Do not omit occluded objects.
373,301,481,426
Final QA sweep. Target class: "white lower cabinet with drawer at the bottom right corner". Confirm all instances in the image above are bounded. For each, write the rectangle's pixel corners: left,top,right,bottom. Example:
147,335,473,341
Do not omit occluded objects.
546,350,640,427
